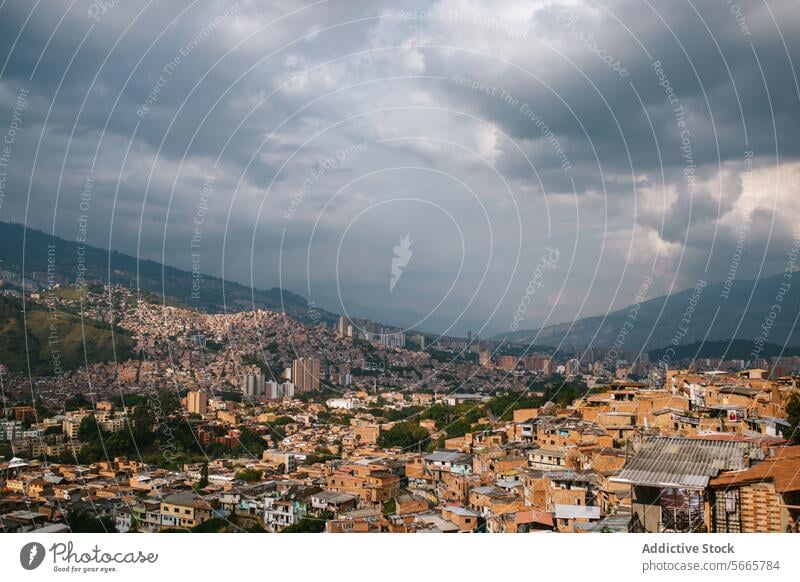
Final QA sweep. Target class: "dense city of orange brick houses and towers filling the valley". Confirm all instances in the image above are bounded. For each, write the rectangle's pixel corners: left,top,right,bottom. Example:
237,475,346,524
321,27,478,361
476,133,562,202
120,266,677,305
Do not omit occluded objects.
0,262,800,533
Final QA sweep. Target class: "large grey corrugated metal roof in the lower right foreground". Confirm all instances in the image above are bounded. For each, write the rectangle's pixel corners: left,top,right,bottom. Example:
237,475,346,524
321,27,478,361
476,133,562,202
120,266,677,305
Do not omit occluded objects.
611,437,746,489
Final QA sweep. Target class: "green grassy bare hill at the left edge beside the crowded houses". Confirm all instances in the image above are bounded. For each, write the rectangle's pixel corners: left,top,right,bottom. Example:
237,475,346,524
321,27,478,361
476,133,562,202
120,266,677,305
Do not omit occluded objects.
0,296,133,376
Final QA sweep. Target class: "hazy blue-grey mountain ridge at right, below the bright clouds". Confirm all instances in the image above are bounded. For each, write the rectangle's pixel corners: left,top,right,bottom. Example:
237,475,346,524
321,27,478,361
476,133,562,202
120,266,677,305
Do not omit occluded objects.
495,272,800,357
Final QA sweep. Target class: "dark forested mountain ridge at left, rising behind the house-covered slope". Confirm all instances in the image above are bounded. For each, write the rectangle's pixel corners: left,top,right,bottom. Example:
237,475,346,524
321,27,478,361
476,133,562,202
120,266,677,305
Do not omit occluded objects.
0,222,324,322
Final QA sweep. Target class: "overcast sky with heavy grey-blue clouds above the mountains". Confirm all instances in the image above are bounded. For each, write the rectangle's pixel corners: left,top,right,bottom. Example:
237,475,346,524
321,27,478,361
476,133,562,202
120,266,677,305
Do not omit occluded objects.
0,0,800,336
